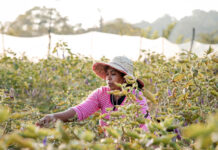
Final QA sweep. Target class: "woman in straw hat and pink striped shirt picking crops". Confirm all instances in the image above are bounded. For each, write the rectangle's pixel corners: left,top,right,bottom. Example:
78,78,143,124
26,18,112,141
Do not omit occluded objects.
36,56,150,130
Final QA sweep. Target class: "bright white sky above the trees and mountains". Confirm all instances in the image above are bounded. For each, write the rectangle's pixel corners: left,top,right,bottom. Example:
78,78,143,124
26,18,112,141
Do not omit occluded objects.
0,0,218,28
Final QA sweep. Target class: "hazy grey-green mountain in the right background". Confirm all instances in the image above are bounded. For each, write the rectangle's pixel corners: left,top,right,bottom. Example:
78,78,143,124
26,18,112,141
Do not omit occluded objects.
134,10,218,42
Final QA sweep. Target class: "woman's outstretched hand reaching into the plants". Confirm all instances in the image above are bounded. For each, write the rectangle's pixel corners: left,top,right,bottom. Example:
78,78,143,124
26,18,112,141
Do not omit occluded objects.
36,114,57,127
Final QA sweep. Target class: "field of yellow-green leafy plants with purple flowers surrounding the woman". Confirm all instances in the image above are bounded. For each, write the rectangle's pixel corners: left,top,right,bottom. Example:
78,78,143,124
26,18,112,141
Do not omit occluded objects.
0,45,218,150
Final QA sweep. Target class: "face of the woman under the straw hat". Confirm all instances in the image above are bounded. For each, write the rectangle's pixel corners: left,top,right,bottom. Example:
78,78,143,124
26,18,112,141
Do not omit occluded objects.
106,67,124,90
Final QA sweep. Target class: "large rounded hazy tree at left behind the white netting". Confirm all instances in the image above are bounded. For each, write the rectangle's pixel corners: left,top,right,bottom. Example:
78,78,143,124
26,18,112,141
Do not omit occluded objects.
7,7,74,36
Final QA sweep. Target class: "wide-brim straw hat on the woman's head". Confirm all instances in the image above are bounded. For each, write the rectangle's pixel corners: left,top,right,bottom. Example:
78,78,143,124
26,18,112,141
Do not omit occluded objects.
92,56,144,88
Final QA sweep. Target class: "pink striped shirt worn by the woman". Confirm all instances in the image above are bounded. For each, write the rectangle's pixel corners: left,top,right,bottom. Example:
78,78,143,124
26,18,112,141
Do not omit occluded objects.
71,86,150,130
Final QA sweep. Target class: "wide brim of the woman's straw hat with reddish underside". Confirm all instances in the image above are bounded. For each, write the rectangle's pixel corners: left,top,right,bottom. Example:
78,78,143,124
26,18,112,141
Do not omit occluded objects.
92,62,144,88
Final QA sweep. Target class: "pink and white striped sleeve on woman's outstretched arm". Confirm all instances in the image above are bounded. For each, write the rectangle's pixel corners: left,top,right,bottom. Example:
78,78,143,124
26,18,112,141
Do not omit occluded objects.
71,89,100,120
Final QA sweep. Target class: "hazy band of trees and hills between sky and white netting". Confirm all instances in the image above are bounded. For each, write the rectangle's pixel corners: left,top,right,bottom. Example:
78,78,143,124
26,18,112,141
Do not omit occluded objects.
0,7,218,44
